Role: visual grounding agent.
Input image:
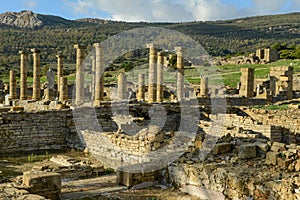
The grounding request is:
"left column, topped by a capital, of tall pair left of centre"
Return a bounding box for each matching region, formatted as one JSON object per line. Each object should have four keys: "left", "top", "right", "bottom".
{"left": 74, "top": 44, "right": 86, "bottom": 105}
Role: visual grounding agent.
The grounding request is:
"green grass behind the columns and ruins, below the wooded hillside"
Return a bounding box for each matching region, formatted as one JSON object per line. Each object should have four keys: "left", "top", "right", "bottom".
{"left": 0, "top": 60, "right": 300, "bottom": 87}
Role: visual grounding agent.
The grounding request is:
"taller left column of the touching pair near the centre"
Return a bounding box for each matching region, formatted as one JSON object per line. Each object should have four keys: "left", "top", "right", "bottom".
{"left": 147, "top": 44, "right": 157, "bottom": 103}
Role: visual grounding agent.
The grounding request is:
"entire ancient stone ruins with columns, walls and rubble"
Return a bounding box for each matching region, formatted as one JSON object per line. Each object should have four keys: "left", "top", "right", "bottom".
{"left": 0, "top": 43, "right": 300, "bottom": 200}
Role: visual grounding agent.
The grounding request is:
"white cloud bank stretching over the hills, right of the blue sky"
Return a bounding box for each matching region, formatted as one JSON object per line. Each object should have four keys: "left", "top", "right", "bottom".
{"left": 69, "top": 0, "right": 299, "bottom": 22}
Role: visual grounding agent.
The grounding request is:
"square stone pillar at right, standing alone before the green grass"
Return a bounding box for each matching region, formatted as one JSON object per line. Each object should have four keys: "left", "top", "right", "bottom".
{"left": 239, "top": 68, "right": 254, "bottom": 98}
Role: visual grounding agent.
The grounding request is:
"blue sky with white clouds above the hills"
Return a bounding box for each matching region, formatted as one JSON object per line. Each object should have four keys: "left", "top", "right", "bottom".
{"left": 0, "top": 0, "right": 300, "bottom": 22}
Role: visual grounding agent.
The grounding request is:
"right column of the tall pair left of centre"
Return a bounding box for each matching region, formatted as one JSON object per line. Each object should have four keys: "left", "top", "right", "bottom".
{"left": 94, "top": 43, "right": 104, "bottom": 106}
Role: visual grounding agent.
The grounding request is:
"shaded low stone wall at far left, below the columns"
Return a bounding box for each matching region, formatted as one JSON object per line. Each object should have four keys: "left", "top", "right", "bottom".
{"left": 0, "top": 111, "right": 69, "bottom": 153}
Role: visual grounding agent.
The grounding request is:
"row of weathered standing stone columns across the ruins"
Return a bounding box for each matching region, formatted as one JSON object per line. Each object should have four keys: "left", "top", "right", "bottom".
{"left": 10, "top": 43, "right": 192, "bottom": 106}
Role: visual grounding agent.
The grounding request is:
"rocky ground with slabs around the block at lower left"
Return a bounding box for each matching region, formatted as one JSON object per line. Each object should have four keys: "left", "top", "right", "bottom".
{"left": 0, "top": 151, "right": 202, "bottom": 200}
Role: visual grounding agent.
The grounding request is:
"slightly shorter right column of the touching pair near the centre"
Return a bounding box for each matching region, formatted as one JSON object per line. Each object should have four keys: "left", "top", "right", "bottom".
{"left": 157, "top": 52, "right": 164, "bottom": 102}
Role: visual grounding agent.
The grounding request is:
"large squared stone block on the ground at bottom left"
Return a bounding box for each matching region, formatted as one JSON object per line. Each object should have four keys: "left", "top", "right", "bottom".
{"left": 23, "top": 171, "right": 61, "bottom": 200}
